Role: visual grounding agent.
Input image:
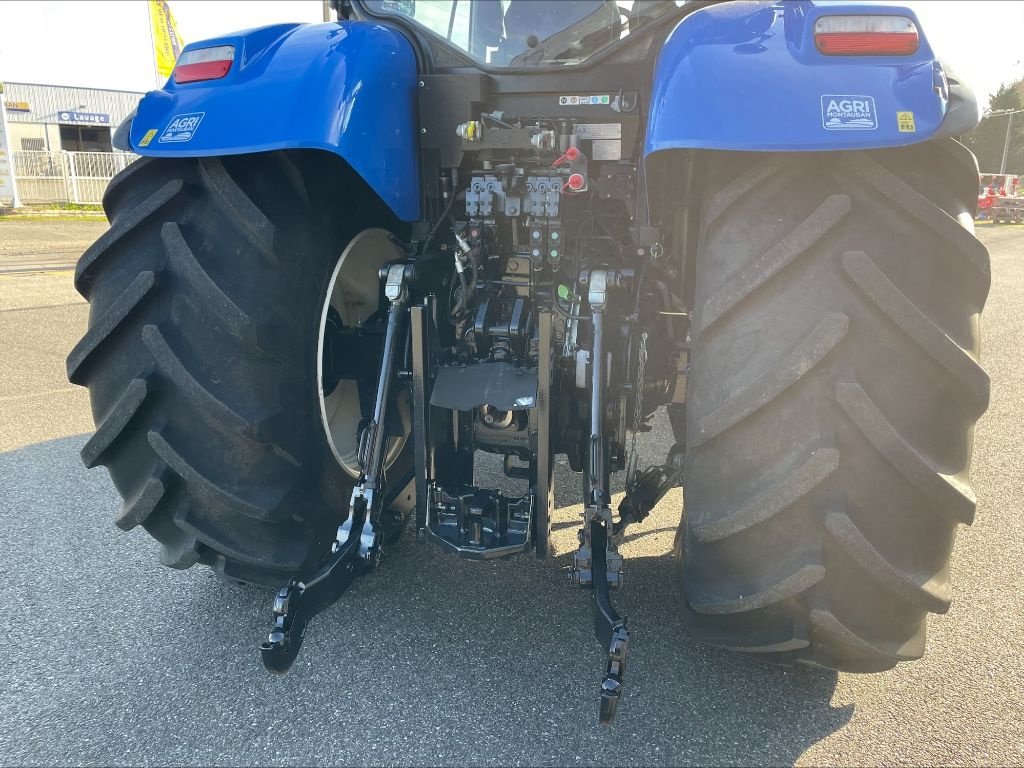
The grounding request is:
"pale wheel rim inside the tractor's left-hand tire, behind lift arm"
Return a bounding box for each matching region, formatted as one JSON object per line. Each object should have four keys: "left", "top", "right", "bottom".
{"left": 316, "top": 229, "right": 412, "bottom": 478}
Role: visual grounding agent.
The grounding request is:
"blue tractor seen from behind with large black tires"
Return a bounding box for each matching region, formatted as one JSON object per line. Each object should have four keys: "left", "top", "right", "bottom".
{"left": 68, "top": 0, "right": 989, "bottom": 722}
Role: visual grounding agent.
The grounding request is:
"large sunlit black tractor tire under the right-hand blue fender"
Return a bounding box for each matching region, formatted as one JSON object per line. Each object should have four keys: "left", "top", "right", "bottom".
{"left": 676, "top": 140, "right": 990, "bottom": 672}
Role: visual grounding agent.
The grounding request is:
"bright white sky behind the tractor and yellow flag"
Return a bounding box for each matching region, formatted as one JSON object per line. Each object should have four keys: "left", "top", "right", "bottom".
{"left": 0, "top": 0, "right": 1024, "bottom": 103}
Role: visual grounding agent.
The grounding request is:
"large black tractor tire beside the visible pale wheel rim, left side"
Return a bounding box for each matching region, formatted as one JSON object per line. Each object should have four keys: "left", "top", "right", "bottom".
{"left": 68, "top": 153, "right": 411, "bottom": 587}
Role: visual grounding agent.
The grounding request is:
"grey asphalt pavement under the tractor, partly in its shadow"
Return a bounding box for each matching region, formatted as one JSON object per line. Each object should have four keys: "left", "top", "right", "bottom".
{"left": 0, "top": 224, "right": 1024, "bottom": 765}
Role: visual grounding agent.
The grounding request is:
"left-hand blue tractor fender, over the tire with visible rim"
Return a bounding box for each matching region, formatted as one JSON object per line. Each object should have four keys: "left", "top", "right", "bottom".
{"left": 129, "top": 22, "right": 420, "bottom": 221}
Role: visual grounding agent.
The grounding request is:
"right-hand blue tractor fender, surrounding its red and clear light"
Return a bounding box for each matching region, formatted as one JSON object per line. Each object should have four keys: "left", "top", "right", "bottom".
{"left": 644, "top": 0, "right": 978, "bottom": 156}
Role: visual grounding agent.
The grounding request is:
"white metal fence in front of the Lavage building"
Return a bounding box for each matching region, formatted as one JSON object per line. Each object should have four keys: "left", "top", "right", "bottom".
{"left": 10, "top": 150, "right": 138, "bottom": 204}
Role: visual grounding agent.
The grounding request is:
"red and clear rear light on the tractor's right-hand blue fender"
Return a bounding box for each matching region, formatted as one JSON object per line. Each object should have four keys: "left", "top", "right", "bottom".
{"left": 814, "top": 15, "right": 921, "bottom": 56}
